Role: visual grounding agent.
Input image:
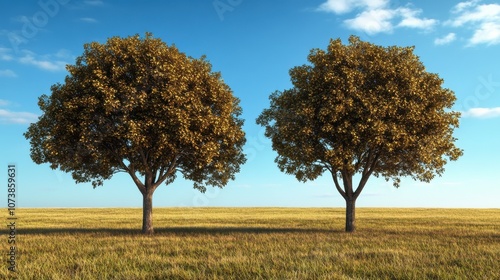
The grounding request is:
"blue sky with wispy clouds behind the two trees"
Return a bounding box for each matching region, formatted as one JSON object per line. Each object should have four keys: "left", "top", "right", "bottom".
{"left": 0, "top": 0, "right": 500, "bottom": 208}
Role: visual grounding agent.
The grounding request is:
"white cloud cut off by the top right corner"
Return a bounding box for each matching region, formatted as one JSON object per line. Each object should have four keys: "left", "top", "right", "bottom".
{"left": 447, "top": 0, "right": 500, "bottom": 45}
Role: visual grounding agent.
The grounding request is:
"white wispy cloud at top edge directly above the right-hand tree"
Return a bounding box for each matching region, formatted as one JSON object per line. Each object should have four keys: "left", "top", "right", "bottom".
{"left": 317, "top": 0, "right": 438, "bottom": 35}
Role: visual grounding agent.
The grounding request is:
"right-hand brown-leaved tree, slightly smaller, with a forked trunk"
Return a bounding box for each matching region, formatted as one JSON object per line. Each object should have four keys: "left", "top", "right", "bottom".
{"left": 257, "top": 36, "right": 462, "bottom": 232}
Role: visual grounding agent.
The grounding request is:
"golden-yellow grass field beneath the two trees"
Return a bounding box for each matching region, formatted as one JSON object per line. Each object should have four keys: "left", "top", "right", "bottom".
{"left": 0, "top": 208, "right": 500, "bottom": 279}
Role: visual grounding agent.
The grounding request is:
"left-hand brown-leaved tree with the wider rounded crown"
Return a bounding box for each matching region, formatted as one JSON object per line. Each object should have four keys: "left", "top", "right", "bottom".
{"left": 25, "top": 33, "right": 245, "bottom": 234}
